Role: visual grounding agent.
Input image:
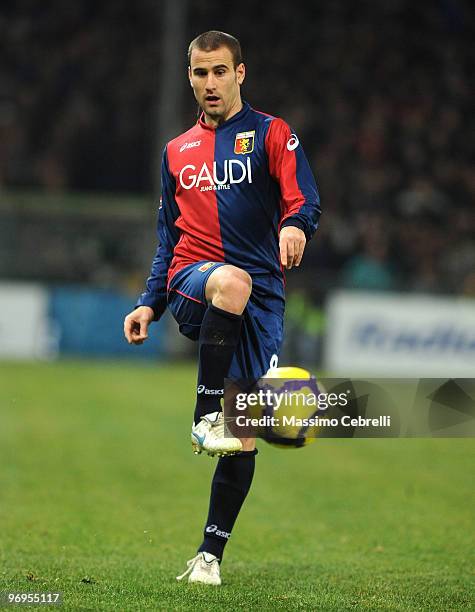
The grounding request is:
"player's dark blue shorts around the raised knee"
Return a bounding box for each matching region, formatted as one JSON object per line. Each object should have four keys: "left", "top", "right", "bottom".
{"left": 168, "top": 261, "right": 285, "bottom": 379}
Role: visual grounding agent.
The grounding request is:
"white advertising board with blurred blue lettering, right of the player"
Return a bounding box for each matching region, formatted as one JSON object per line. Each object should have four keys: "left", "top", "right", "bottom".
{"left": 325, "top": 291, "right": 475, "bottom": 377}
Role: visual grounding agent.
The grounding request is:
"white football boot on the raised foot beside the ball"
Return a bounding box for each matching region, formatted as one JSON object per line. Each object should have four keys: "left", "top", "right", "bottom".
{"left": 191, "top": 412, "right": 242, "bottom": 457}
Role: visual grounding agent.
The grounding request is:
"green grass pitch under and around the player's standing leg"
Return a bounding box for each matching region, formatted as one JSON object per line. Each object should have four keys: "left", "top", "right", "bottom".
{"left": 0, "top": 361, "right": 475, "bottom": 611}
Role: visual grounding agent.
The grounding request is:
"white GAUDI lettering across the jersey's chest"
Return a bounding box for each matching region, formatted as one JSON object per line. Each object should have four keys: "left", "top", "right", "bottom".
{"left": 178, "top": 157, "right": 252, "bottom": 191}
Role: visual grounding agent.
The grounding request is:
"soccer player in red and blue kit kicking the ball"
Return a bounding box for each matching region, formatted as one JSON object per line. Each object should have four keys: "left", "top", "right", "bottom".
{"left": 124, "top": 31, "right": 320, "bottom": 585}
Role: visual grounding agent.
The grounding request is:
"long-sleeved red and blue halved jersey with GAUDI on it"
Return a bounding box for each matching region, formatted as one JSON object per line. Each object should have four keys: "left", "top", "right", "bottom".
{"left": 137, "top": 102, "right": 320, "bottom": 318}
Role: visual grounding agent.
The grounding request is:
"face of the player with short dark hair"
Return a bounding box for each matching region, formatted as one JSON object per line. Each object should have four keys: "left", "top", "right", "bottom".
{"left": 188, "top": 47, "right": 245, "bottom": 123}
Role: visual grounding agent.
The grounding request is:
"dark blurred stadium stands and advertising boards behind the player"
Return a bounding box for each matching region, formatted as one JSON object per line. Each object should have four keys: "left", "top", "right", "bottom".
{"left": 0, "top": 0, "right": 475, "bottom": 375}
